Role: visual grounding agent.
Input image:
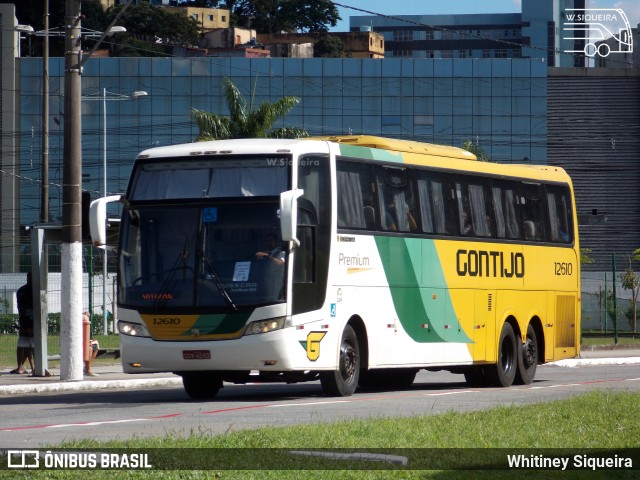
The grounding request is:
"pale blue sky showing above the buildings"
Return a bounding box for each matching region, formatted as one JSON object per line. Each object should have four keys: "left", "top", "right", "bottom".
{"left": 331, "top": 0, "right": 640, "bottom": 31}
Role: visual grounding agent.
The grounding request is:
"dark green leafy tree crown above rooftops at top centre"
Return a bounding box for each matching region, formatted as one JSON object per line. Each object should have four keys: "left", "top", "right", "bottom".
{"left": 226, "top": 0, "right": 340, "bottom": 33}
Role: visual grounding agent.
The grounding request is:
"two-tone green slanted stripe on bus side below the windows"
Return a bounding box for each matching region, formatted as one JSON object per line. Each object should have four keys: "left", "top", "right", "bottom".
{"left": 375, "top": 236, "right": 471, "bottom": 343}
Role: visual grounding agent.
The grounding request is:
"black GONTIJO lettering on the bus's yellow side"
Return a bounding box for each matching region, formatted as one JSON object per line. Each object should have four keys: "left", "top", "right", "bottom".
{"left": 456, "top": 249, "right": 524, "bottom": 278}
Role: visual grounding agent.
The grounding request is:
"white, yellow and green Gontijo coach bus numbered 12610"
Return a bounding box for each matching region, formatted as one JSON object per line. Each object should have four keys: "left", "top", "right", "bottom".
{"left": 90, "top": 136, "right": 580, "bottom": 399}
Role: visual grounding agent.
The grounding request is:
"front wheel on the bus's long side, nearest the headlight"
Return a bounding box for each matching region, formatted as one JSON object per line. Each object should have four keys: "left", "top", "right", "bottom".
{"left": 320, "top": 325, "right": 361, "bottom": 397}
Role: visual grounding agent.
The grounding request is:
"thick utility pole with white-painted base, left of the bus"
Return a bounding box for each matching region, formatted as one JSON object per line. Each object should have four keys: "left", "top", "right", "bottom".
{"left": 60, "top": 0, "right": 83, "bottom": 380}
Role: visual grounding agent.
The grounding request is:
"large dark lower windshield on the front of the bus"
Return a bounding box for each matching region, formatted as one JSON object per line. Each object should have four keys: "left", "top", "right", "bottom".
{"left": 119, "top": 201, "right": 286, "bottom": 311}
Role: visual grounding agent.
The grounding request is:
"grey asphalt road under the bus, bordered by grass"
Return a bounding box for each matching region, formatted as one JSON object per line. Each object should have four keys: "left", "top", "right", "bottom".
{"left": 0, "top": 363, "right": 640, "bottom": 449}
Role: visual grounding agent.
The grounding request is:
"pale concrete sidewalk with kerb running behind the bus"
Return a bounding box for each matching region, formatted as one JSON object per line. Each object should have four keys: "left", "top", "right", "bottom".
{"left": 0, "top": 345, "right": 640, "bottom": 396}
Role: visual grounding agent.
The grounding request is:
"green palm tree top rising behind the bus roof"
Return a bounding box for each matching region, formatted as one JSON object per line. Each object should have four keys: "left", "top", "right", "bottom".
{"left": 191, "top": 78, "right": 309, "bottom": 142}
